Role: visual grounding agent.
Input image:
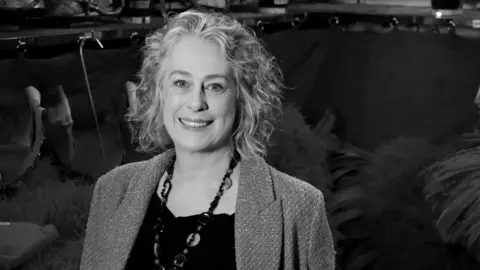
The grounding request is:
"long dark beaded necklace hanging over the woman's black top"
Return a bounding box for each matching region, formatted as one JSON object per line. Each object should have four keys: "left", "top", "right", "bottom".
{"left": 153, "top": 151, "right": 240, "bottom": 270}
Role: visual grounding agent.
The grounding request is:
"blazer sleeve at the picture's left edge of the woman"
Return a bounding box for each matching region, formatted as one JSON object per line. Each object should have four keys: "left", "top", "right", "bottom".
{"left": 80, "top": 178, "right": 107, "bottom": 270}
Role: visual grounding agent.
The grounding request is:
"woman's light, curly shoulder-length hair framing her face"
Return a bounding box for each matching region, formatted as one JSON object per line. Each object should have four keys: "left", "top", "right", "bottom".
{"left": 127, "top": 10, "right": 284, "bottom": 157}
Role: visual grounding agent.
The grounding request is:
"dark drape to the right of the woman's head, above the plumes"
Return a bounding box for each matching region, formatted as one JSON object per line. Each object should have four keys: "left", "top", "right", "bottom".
{"left": 265, "top": 30, "right": 480, "bottom": 148}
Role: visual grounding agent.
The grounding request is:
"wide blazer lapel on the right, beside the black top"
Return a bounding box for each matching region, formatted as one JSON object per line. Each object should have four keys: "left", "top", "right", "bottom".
{"left": 235, "top": 158, "right": 283, "bottom": 270}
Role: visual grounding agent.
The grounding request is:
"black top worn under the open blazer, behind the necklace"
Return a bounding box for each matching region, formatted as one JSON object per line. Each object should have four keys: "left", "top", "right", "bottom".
{"left": 125, "top": 193, "right": 236, "bottom": 270}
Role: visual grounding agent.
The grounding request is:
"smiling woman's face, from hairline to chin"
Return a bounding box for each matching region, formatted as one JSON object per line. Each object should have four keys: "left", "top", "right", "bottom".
{"left": 163, "top": 36, "right": 236, "bottom": 152}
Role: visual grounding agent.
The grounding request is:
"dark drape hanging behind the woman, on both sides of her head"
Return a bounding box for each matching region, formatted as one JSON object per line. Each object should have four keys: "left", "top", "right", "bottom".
{"left": 0, "top": 30, "right": 480, "bottom": 151}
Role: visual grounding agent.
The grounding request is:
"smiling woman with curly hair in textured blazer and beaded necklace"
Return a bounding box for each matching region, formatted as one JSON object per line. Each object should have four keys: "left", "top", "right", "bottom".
{"left": 80, "top": 8, "right": 334, "bottom": 270}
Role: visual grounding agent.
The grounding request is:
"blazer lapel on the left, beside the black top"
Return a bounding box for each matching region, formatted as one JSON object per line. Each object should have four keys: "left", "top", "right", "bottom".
{"left": 106, "top": 150, "right": 173, "bottom": 269}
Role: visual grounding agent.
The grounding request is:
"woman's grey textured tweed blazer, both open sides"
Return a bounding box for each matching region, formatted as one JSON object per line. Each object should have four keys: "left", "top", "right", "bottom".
{"left": 80, "top": 150, "right": 335, "bottom": 270}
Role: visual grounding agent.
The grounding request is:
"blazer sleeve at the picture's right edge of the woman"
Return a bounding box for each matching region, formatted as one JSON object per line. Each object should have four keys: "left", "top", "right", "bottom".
{"left": 308, "top": 193, "right": 335, "bottom": 270}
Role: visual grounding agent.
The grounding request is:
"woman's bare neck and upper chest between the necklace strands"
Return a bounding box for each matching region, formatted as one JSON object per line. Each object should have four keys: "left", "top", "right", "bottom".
{"left": 174, "top": 147, "right": 233, "bottom": 186}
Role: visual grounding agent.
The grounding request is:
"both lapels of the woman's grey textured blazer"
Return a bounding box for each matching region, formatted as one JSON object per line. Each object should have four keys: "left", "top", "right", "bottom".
{"left": 108, "top": 150, "right": 283, "bottom": 269}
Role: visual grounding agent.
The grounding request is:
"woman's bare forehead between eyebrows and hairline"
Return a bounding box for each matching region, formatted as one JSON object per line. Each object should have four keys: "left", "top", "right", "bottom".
{"left": 170, "top": 36, "right": 229, "bottom": 74}
